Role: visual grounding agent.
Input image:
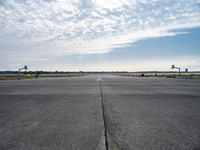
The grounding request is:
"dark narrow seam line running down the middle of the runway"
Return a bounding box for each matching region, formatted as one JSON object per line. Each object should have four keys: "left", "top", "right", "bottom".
{"left": 99, "top": 79, "right": 108, "bottom": 150}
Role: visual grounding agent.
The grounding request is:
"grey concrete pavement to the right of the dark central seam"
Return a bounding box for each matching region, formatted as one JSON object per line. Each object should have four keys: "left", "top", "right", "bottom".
{"left": 102, "top": 77, "right": 200, "bottom": 150}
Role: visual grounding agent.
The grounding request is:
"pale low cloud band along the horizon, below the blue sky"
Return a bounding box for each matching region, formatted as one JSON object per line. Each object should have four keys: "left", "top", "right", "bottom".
{"left": 65, "top": 56, "right": 200, "bottom": 72}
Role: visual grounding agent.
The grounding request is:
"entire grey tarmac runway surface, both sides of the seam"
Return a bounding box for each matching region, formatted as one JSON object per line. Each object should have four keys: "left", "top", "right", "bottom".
{"left": 0, "top": 75, "right": 200, "bottom": 150}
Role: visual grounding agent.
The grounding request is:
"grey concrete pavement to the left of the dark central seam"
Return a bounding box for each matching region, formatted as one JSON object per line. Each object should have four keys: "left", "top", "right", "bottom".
{"left": 0, "top": 77, "right": 105, "bottom": 150}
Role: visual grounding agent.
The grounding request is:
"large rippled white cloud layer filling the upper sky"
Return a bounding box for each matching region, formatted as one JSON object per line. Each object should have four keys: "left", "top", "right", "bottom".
{"left": 0, "top": 0, "right": 200, "bottom": 57}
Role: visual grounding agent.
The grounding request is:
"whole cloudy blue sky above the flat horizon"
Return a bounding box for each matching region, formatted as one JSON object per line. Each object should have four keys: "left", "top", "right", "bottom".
{"left": 0, "top": 0, "right": 200, "bottom": 71}
